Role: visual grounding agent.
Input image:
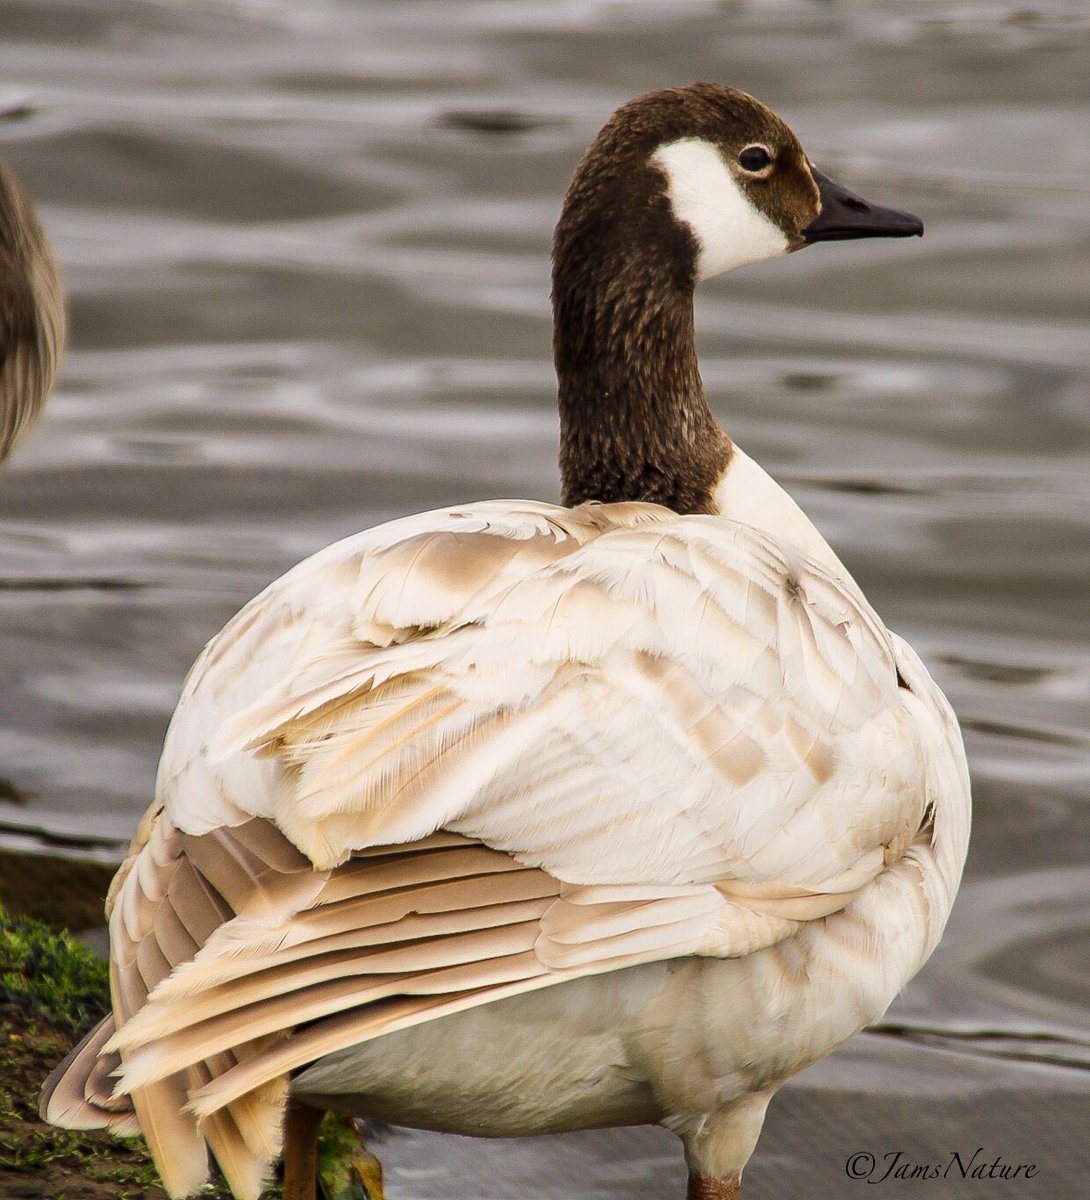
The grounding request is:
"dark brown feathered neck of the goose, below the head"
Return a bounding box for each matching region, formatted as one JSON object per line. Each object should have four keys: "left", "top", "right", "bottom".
{"left": 553, "top": 201, "right": 730, "bottom": 512}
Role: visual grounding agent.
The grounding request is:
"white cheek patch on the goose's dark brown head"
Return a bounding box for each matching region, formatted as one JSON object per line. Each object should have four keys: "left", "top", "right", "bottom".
{"left": 651, "top": 138, "right": 787, "bottom": 280}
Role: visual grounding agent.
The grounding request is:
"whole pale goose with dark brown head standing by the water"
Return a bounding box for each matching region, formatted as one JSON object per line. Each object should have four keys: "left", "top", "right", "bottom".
{"left": 42, "top": 84, "right": 970, "bottom": 1200}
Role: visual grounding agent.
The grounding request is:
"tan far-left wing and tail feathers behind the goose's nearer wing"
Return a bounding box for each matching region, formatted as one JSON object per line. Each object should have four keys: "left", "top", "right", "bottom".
{"left": 42, "top": 806, "right": 323, "bottom": 1196}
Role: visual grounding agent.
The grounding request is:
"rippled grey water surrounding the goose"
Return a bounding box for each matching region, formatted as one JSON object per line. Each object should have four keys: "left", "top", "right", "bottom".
{"left": 0, "top": 0, "right": 1090, "bottom": 1200}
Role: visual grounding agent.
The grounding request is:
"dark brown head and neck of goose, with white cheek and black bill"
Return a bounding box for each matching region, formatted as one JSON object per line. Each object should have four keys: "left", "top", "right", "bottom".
{"left": 552, "top": 84, "right": 923, "bottom": 512}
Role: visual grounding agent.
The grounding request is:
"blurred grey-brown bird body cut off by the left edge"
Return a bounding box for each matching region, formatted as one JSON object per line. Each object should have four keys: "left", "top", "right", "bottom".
{"left": 0, "top": 151, "right": 65, "bottom": 462}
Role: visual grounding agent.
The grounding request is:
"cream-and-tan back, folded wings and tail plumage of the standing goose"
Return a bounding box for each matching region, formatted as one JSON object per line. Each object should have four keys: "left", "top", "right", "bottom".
{"left": 47, "top": 502, "right": 965, "bottom": 1195}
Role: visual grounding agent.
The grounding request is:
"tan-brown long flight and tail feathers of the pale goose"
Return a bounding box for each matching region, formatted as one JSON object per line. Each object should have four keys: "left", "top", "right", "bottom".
{"left": 42, "top": 809, "right": 558, "bottom": 1198}
